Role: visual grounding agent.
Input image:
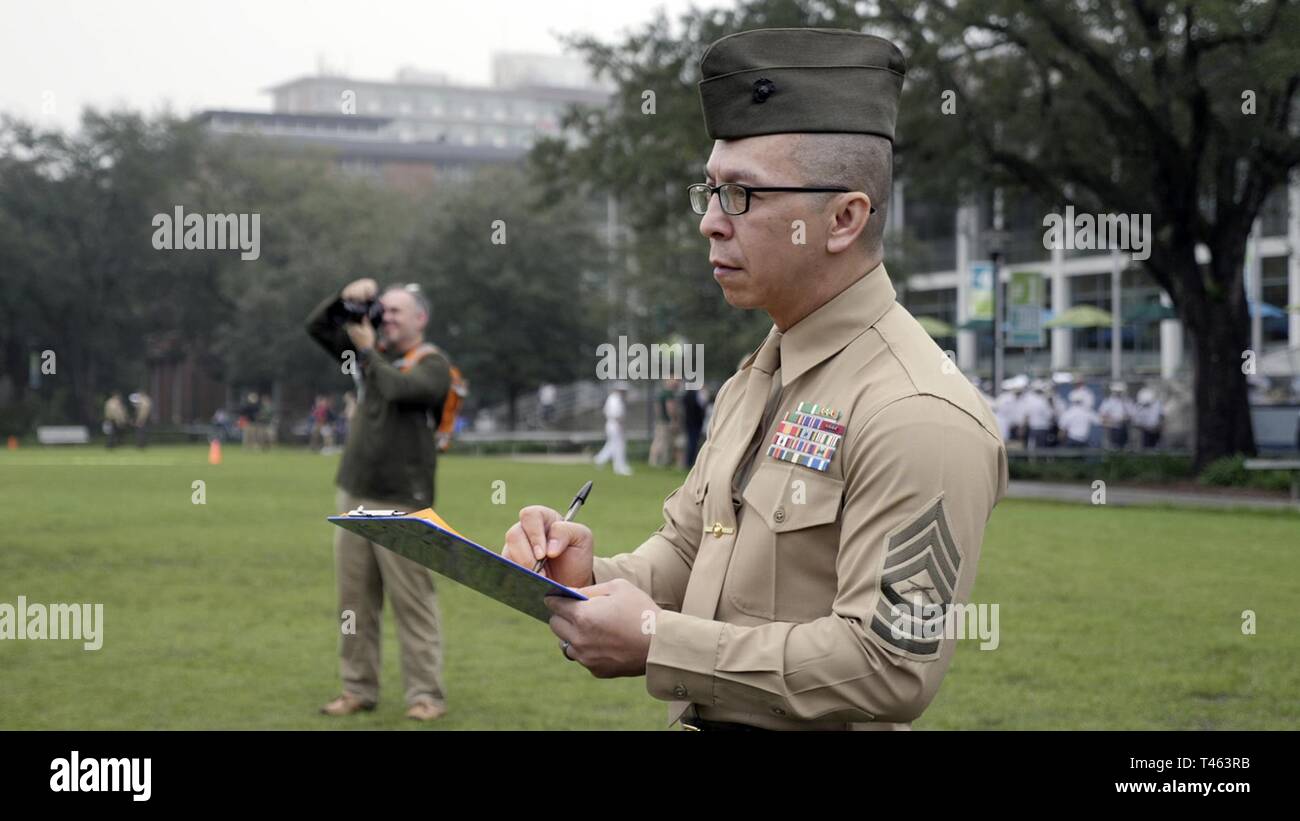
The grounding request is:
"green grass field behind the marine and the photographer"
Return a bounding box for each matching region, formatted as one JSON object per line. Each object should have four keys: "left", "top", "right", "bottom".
{"left": 0, "top": 447, "right": 1300, "bottom": 730}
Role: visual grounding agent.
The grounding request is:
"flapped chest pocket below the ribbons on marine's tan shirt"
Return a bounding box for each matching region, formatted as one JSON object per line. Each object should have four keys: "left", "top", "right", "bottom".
{"left": 724, "top": 457, "right": 844, "bottom": 622}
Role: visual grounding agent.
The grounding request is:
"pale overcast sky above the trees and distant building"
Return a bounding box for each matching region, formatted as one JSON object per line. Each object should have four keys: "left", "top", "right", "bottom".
{"left": 0, "top": 0, "right": 712, "bottom": 129}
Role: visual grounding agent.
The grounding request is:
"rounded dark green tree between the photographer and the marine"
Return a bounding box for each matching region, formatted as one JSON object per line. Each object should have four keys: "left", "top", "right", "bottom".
{"left": 403, "top": 168, "right": 603, "bottom": 430}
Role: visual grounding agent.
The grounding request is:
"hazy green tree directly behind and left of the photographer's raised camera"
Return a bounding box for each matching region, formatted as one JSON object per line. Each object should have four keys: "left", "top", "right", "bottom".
{"left": 195, "top": 139, "right": 416, "bottom": 397}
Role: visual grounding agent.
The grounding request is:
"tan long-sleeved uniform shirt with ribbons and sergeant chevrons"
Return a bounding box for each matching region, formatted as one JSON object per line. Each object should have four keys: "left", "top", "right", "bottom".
{"left": 594, "top": 265, "right": 1006, "bottom": 730}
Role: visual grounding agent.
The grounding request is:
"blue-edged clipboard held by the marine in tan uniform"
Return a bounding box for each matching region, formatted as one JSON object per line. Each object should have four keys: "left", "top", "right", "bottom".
{"left": 329, "top": 508, "right": 586, "bottom": 622}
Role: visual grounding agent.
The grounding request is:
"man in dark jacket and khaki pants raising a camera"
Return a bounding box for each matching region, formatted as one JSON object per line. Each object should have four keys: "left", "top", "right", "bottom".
{"left": 307, "top": 279, "right": 451, "bottom": 721}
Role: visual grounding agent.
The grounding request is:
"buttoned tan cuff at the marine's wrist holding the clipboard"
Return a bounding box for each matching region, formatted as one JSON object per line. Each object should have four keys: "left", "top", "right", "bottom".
{"left": 646, "top": 611, "right": 725, "bottom": 707}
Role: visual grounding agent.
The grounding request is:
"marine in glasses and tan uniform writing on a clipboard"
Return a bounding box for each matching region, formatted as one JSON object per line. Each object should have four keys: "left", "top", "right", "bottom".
{"left": 504, "top": 29, "right": 1006, "bottom": 730}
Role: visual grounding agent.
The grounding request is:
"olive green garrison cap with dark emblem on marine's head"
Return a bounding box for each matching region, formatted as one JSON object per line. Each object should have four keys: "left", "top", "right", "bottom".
{"left": 699, "top": 29, "right": 907, "bottom": 143}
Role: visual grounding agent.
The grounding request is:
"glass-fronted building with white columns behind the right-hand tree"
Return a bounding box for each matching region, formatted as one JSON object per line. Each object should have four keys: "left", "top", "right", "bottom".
{"left": 891, "top": 181, "right": 1300, "bottom": 379}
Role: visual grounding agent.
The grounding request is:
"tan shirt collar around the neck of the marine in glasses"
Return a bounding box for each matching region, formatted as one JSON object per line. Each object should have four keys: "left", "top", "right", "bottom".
{"left": 772, "top": 262, "right": 894, "bottom": 385}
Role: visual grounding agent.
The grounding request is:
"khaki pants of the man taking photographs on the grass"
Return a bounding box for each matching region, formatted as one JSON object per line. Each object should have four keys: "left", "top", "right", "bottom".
{"left": 334, "top": 490, "right": 446, "bottom": 705}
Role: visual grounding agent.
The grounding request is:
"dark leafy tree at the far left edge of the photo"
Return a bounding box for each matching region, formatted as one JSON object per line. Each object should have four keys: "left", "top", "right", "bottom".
{"left": 0, "top": 110, "right": 216, "bottom": 423}
